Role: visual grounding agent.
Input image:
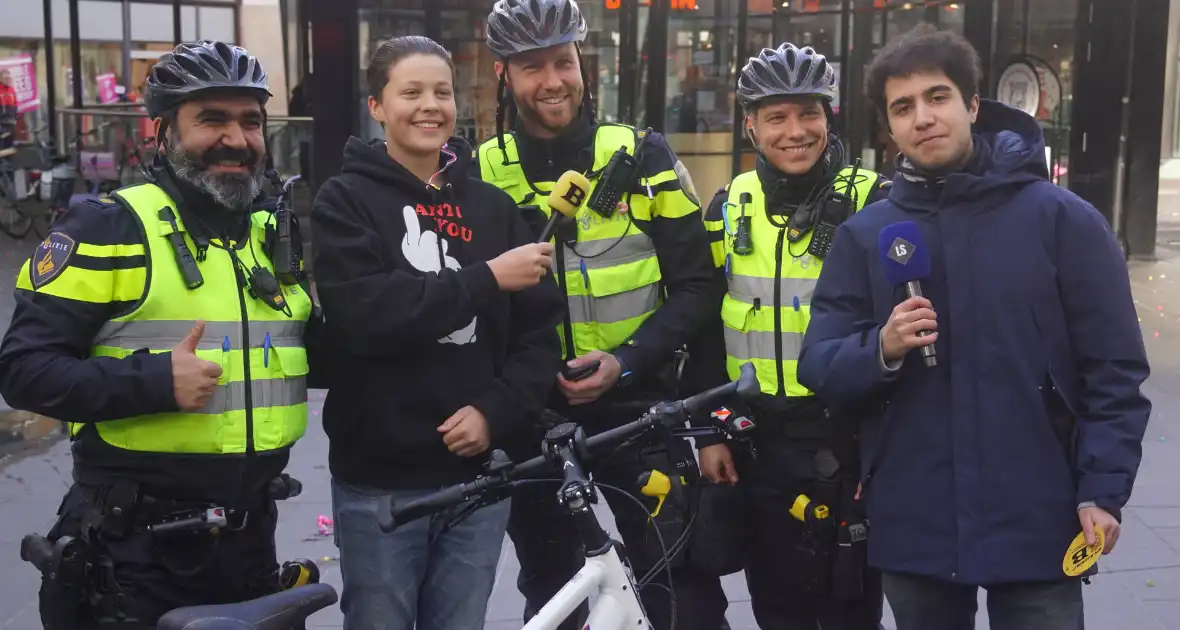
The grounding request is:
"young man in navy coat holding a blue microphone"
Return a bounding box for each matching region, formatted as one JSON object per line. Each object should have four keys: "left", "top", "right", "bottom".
{"left": 799, "top": 27, "right": 1151, "bottom": 630}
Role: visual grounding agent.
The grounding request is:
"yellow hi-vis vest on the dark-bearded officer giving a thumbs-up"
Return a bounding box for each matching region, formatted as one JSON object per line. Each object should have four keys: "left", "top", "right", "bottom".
{"left": 70, "top": 184, "right": 312, "bottom": 454}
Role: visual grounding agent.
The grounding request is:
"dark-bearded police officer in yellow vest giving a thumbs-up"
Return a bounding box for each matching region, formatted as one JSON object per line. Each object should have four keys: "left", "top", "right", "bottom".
{"left": 0, "top": 41, "right": 313, "bottom": 629}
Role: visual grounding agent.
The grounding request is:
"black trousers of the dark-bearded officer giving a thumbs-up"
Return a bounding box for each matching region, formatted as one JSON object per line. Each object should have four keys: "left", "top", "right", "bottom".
{"left": 40, "top": 486, "right": 280, "bottom": 630}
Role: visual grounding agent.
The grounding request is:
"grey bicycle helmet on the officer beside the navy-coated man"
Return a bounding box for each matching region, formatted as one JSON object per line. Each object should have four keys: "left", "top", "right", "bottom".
{"left": 738, "top": 44, "right": 837, "bottom": 109}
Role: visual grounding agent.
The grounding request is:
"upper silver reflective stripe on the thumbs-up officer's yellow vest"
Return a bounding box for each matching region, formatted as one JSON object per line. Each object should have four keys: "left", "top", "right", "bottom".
{"left": 94, "top": 320, "right": 304, "bottom": 350}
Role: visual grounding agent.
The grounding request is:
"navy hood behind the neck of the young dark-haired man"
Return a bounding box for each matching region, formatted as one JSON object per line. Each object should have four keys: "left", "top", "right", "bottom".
{"left": 890, "top": 99, "right": 1049, "bottom": 211}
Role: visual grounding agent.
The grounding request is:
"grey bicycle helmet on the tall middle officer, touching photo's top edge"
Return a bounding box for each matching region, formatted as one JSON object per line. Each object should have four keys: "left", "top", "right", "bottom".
{"left": 487, "top": 0, "right": 586, "bottom": 57}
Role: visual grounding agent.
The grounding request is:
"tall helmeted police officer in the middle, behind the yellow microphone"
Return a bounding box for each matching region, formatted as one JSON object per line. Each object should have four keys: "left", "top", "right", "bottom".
{"left": 476, "top": 0, "right": 726, "bottom": 630}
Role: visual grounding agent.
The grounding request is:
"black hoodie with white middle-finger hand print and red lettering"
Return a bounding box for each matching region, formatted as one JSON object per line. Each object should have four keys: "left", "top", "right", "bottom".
{"left": 312, "top": 138, "right": 565, "bottom": 488}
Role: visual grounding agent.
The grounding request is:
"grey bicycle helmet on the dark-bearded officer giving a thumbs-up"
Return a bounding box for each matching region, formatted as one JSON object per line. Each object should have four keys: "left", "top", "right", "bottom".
{"left": 144, "top": 40, "right": 271, "bottom": 118}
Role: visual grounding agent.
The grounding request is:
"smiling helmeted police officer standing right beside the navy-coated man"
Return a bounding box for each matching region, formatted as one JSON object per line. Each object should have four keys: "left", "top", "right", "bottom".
{"left": 696, "top": 44, "right": 887, "bottom": 630}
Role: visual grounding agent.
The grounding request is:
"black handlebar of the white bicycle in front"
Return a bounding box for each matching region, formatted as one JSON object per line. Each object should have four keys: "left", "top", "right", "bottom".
{"left": 380, "top": 363, "right": 760, "bottom": 533}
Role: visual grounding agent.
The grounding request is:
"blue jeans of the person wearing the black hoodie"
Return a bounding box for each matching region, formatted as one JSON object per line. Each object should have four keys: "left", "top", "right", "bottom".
{"left": 332, "top": 479, "right": 510, "bottom": 630}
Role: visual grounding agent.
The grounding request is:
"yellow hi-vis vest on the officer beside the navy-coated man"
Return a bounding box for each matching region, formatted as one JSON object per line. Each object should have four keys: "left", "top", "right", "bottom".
{"left": 713, "top": 166, "right": 878, "bottom": 396}
